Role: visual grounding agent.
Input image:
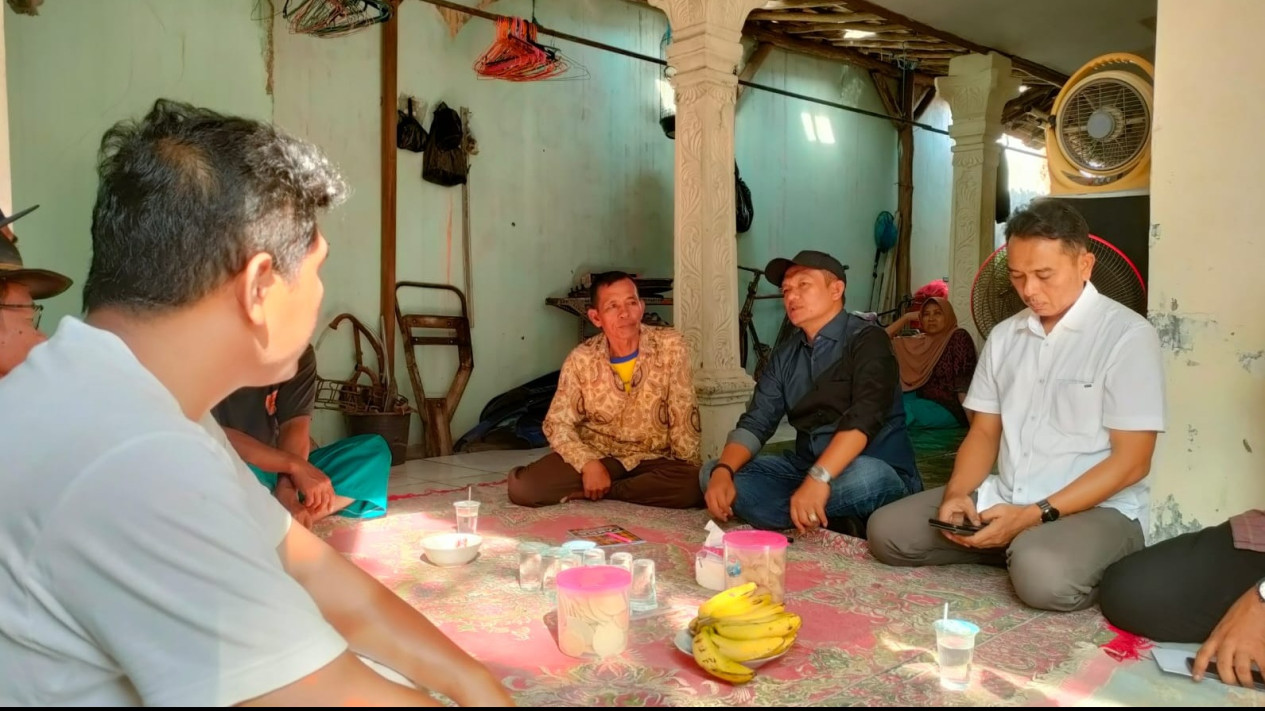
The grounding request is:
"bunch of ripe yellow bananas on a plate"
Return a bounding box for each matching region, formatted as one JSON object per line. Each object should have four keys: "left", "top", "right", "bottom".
{"left": 689, "top": 582, "right": 802, "bottom": 684}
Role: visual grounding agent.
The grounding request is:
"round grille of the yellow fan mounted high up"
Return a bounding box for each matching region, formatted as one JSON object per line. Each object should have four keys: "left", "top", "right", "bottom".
{"left": 1058, "top": 77, "right": 1151, "bottom": 173}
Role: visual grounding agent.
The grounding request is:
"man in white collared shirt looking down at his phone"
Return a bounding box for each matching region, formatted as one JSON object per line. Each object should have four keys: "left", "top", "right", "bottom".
{"left": 869, "top": 200, "right": 1164, "bottom": 610}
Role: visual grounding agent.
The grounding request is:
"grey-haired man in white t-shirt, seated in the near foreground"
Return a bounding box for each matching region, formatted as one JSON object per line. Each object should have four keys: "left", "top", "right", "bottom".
{"left": 0, "top": 100, "right": 510, "bottom": 706}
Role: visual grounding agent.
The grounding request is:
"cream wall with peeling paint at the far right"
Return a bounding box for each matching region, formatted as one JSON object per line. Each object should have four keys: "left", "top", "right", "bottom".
{"left": 1150, "top": 0, "right": 1265, "bottom": 539}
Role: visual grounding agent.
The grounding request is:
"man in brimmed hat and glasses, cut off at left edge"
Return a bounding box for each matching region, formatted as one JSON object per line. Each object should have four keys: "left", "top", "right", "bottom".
{"left": 0, "top": 205, "right": 71, "bottom": 377}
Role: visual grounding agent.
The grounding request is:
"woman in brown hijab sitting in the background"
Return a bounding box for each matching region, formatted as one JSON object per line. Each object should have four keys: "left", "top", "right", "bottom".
{"left": 888, "top": 296, "right": 978, "bottom": 429}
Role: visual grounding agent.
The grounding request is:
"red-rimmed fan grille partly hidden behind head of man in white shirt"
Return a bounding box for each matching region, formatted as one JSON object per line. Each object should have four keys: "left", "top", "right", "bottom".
{"left": 970, "top": 234, "right": 1146, "bottom": 338}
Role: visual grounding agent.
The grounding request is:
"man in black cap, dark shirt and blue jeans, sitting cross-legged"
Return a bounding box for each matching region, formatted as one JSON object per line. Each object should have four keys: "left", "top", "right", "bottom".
{"left": 700, "top": 250, "right": 922, "bottom": 536}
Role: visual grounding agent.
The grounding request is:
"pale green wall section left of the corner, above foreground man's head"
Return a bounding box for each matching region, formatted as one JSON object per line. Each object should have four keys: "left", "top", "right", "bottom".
{"left": 4, "top": 0, "right": 272, "bottom": 323}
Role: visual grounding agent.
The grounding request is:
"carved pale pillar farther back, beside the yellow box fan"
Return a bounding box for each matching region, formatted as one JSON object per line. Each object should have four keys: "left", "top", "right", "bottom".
{"left": 936, "top": 52, "right": 1020, "bottom": 344}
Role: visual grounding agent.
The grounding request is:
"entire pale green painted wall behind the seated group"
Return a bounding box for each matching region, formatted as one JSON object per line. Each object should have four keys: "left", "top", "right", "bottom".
{"left": 5, "top": 0, "right": 947, "bottom": 447}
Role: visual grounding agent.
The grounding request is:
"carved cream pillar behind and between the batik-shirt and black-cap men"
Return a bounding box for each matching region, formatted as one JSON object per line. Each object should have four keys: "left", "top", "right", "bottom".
{"left": 650, "top": 0, "right": 764, "bottom": 459}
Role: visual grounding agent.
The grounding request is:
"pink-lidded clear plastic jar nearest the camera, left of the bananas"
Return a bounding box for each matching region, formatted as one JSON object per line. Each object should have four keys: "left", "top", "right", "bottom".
{"left": 558, "top": 566, "right": 633, "bottom": 658}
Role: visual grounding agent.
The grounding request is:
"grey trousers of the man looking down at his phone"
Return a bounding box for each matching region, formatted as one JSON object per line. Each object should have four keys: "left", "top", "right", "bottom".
{"left": 867, "top": 487, "right": 1144, "bottom": 612}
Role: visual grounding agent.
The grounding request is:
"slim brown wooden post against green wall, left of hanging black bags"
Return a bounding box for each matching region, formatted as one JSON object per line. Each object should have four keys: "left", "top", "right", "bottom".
{"left": 378, "top": 1, "right": 397, "bottom": 374}
